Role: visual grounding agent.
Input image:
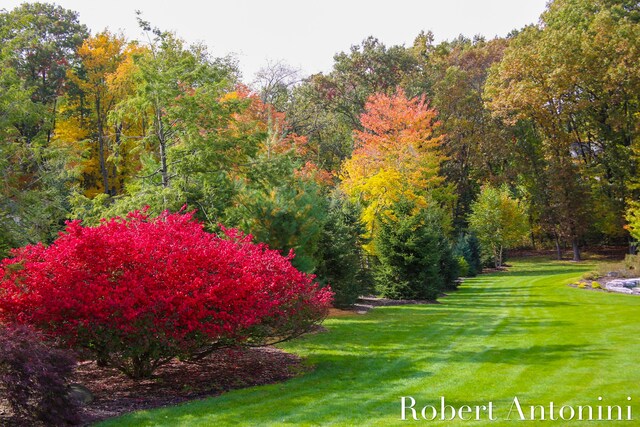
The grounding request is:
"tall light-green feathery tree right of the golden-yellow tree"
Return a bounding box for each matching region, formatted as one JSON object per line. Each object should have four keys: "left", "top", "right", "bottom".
{"left": 106, "top": 20, "right": 241, "bottom": 214}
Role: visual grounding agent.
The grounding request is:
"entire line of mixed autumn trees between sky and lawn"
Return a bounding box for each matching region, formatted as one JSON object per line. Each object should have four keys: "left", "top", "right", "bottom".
{"left": 0, "top": 0, "right": 640, "bottom": 304}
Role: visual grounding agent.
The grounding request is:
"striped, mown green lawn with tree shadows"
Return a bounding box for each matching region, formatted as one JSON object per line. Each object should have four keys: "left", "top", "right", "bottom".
{"left": 101, "top": 262, "right": 640, "bottom": 426}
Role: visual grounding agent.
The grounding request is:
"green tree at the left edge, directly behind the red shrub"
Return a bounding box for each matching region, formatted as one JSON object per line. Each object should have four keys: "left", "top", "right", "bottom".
{"left": 0, "top": 50, "right": 70, "bottom": 258}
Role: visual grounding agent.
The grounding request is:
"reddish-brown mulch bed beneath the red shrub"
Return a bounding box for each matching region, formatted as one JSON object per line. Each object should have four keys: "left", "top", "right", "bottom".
{"left": 0, "top": 347, "right": 310, "bottom": 426}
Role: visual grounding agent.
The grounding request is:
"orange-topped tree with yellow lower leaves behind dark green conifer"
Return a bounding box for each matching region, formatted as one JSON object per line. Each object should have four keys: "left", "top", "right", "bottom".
{"left": 341, "top": 89, "right": 450, "bottom": 247}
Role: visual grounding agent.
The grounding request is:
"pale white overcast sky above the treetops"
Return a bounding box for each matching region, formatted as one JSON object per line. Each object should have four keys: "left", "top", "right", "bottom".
{"left": 0, "top": 0, "right": 546, "bottom": 82}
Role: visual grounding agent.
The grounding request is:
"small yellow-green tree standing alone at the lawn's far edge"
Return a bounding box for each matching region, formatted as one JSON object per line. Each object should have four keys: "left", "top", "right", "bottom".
{"left": 469, "top": 186, "right": 529, "bottom": 268}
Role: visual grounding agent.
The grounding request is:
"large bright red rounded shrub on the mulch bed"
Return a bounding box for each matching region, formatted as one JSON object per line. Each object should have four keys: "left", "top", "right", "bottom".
{"left": 0, "top": 211, "right": 331, "bottom": 377}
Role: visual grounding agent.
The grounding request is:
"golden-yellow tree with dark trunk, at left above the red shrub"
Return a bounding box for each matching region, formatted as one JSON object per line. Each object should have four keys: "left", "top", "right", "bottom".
{"left": 56, "top": 31, "right": 144, "bottom": 197}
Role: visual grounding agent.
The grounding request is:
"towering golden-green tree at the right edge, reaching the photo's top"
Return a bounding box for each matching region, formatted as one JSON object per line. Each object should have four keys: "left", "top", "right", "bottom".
{"left": 486, "top": 0, "right": 640, "bottom": 260}
